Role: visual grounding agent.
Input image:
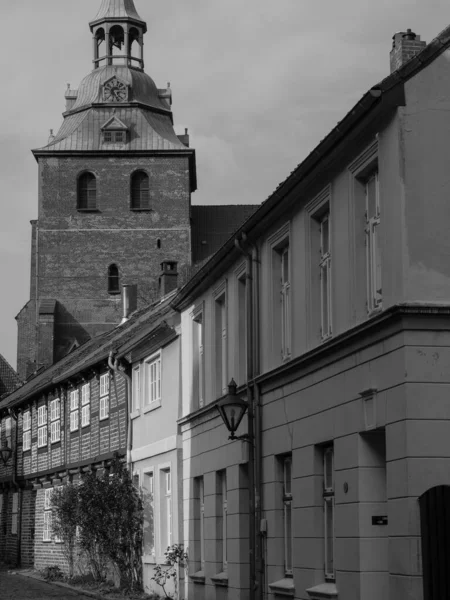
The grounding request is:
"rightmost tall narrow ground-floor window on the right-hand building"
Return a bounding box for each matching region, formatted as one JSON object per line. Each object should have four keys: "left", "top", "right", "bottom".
{"left": 323, "top": 446, "right": 335, "bottom": 581}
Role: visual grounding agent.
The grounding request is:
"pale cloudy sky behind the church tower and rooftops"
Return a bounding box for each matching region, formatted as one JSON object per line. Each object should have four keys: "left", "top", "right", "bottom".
{"left": 0, "top": 0, "right": 450, "bottom": 367}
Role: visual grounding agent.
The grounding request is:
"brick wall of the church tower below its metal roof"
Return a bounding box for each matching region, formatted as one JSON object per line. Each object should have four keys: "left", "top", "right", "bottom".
{"left": 33, "top": 156, "right": 190, "bottom": 360}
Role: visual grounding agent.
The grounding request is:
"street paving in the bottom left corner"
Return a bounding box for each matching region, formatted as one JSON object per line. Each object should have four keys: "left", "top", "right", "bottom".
{"left": 0, "top": 571, "right": 92, "bottom": 600}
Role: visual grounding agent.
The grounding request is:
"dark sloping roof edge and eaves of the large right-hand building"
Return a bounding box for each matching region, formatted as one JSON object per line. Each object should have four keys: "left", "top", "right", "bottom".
{"left": 172, "top": 26, "right": 450, "bottom": 310}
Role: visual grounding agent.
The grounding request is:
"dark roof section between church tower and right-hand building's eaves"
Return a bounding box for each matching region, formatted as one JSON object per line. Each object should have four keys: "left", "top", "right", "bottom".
{"left": 191, "top": 204, "right": 259, "bottom": 264}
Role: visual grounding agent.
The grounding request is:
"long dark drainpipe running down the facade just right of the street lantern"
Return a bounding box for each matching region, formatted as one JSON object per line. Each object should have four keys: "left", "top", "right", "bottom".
{"left": 235, "top": 234, "right": 263, "bottom": 600}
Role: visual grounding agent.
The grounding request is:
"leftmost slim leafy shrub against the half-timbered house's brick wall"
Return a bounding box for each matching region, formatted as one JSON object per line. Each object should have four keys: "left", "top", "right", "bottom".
{"left": 51, "top": 483, "right": 79, "bottom": 579}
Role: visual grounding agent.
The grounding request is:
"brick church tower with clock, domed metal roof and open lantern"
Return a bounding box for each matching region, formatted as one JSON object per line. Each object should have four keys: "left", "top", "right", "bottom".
{"left": 17, "top": 0, "right": 196, "bottom": 378}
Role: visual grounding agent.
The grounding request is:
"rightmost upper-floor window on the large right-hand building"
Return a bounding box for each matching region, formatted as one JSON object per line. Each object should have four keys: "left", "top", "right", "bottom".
{"left": 365, "top": 168, "right": 383, "bottom": 314}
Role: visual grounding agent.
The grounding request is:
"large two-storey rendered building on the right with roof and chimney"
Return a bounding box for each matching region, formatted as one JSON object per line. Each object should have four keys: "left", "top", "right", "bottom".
{"left": 174, "top": 29, "right": 450, "bottom": 600}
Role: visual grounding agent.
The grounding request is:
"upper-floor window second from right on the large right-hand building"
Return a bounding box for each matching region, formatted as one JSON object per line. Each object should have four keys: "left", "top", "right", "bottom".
{"left": 319, "top": 210, "right": 333, "bottom": 340}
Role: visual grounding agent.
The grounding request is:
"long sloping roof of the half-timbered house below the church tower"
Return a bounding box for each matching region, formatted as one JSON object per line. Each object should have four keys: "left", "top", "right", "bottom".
{"left": 0, "top": 296, "right": 173, "bottom": 409}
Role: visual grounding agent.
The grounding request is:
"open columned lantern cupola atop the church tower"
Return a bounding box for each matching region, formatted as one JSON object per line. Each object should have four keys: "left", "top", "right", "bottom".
{"left": 89, "top": 0, "right": 147, "bottom": 69}
